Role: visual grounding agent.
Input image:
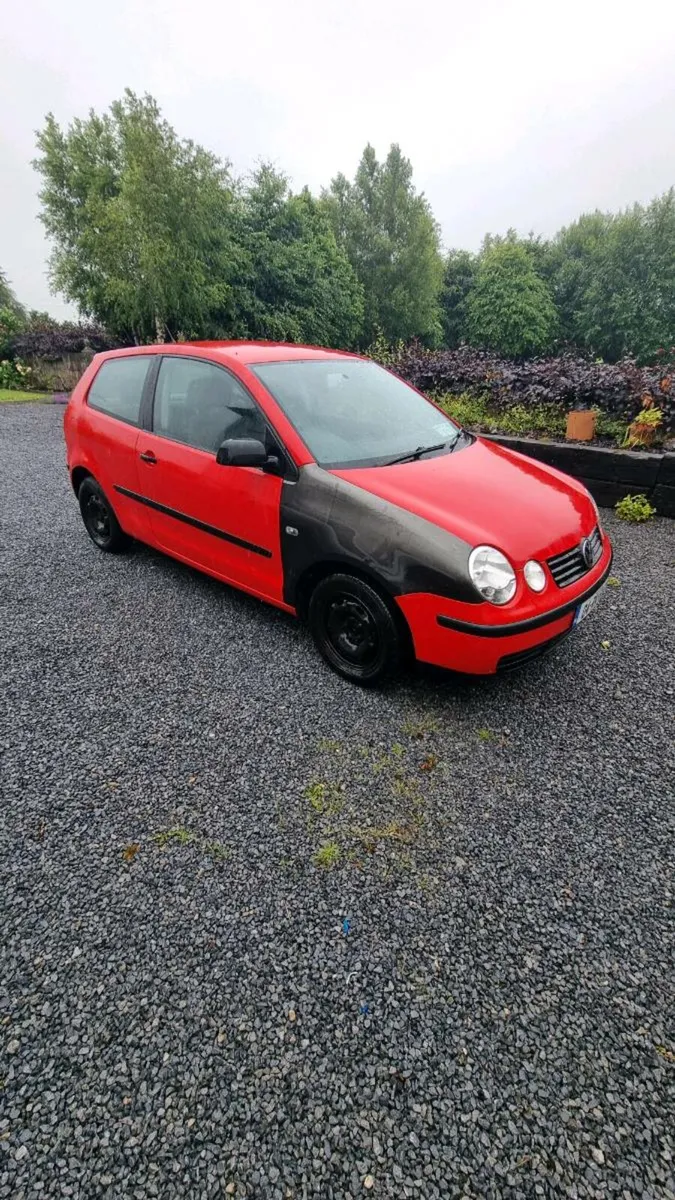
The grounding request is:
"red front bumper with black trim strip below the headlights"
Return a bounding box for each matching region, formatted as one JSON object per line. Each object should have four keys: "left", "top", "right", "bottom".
{"left": 398, "top": 535, "right": 613, "bottom": 674}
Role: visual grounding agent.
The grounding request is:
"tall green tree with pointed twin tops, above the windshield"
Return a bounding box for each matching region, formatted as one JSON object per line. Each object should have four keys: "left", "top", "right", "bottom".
{"left": 323, "top": 145, "right": 443, "bottom": 344}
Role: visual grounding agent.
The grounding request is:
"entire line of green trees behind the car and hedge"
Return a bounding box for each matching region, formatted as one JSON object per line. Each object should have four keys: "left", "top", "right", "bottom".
{"left": 30, "top": 90, "right": 675, "bottom": 364}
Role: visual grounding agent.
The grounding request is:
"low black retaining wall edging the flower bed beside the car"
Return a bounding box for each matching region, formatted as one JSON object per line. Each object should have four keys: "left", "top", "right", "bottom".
{"left": 480, "top": 433, "right": 675, "bottom": 517}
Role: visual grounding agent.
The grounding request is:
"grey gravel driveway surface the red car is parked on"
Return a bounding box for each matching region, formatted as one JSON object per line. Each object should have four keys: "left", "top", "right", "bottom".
{"left": 0, "top": 406, "right": 675, "bottom": 1200}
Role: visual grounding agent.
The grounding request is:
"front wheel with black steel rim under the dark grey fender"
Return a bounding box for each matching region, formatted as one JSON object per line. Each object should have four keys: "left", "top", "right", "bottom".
{"left": 307, "top": 575, "right": 404, "bottom": 686}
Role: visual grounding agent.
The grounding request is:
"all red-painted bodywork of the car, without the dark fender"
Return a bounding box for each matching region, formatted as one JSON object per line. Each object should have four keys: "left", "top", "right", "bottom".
{"left": 64, "top": 342, "right": 611, "bottom": 673}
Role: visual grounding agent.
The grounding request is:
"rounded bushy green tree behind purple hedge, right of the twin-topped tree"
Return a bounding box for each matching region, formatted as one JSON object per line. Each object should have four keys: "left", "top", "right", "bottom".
{"left": 467, "top": 239, "right": 557, "bottom": 358}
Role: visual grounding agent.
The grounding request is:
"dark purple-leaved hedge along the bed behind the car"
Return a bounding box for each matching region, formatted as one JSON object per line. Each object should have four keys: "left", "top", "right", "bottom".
{"left": 372, "top": 344, "right": 675, "bottom": 432}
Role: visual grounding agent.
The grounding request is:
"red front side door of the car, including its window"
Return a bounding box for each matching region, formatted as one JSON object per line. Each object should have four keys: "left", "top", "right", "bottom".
{"left": 137, "top": 355, "right": 283, "bottom": 602}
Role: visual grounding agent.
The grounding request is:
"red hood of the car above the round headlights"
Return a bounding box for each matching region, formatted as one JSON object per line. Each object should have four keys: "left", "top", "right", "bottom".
{"left": 331, "top": 438, "right": 597, "bottom": 566}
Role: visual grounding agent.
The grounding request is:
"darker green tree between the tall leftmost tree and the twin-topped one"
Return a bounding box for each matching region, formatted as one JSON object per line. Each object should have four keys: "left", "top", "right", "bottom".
{"left": 225, "top": 166, "right": 363, "bottom": 347}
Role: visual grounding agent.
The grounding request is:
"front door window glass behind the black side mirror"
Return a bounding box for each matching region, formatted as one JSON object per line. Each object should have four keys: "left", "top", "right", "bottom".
{"left": 153, "top": 356, "right": 265, "bottom": 454}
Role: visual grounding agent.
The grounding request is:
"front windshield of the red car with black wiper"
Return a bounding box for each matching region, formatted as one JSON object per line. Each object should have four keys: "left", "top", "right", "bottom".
{"left": 251, "top": 358, "right": 458, "bottom": 467}
